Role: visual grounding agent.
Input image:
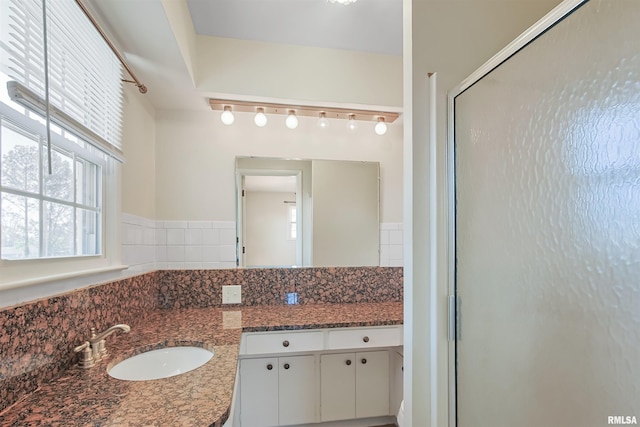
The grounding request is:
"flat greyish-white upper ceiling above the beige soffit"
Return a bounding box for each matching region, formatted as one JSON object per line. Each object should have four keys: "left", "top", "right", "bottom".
{"left": 187, "top": 0, "right": 402, "bottom": 55}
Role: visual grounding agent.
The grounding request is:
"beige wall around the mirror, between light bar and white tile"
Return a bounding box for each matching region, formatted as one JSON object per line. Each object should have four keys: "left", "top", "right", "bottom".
{"left": 156, "top": 111, "right": 402, "bottom": 222}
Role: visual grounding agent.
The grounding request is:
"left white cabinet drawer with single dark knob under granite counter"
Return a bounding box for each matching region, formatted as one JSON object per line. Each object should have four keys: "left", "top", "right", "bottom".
{"left": 246, "top": 331, "right": 324, "bottom": 354}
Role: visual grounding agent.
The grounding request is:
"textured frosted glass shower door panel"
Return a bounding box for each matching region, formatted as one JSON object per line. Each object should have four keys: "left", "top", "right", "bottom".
{"left": 454, "top": 0, "right": 640, "bottom": 427}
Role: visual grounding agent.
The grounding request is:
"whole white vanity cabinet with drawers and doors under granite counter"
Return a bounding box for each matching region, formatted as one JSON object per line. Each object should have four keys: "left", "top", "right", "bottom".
{"left": 234, "top": 325, "right": 402, "bottom": 427}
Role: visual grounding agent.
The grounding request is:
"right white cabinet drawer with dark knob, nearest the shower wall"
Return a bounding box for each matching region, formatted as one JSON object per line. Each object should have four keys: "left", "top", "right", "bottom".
{"left": 327, "top": 326, "right": 402, "bottom": 350}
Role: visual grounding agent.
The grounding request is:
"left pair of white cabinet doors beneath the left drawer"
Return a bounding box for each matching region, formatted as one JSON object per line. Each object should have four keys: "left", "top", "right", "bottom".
{"left": 240, "top": 355, "right": 317, "bottom": 427}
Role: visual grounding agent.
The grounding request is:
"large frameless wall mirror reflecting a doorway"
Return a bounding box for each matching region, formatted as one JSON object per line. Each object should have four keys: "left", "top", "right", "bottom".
{"left": 236, "top": 157, "right": 380, "bottom": 267}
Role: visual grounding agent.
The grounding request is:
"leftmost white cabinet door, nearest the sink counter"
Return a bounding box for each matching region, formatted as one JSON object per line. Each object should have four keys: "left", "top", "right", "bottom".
{"left": 240, "top": 358, "right": 278, "bottom": 427}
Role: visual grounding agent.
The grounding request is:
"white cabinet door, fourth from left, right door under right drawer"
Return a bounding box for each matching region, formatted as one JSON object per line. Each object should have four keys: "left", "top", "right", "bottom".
{"left": 356, "top": 350, "right": 389, "bottom": 418}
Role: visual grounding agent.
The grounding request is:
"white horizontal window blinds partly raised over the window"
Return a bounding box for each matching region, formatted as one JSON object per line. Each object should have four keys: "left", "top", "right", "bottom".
{"left": 0, "top": 0, "right": 122, "bottom": 159}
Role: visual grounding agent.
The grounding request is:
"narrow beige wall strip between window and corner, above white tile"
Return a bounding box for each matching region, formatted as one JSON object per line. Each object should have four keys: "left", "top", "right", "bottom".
{"left": 122, "top": 85, "right": 156, "bottom": 219}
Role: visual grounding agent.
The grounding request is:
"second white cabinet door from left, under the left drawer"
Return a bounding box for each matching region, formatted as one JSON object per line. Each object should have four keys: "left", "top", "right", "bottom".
{"left": 278, "top": 356, "right": 316, "bottom": 426}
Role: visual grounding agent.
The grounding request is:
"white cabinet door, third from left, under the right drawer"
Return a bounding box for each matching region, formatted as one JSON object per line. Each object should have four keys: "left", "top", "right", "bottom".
{"left": 320, "top": 353, "right": 356, "bottom": 421}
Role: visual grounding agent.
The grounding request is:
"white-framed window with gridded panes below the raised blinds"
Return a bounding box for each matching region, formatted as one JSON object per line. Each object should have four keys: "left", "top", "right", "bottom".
{"left": 0, "top": 104, "right": 105, "bottom": 260}
